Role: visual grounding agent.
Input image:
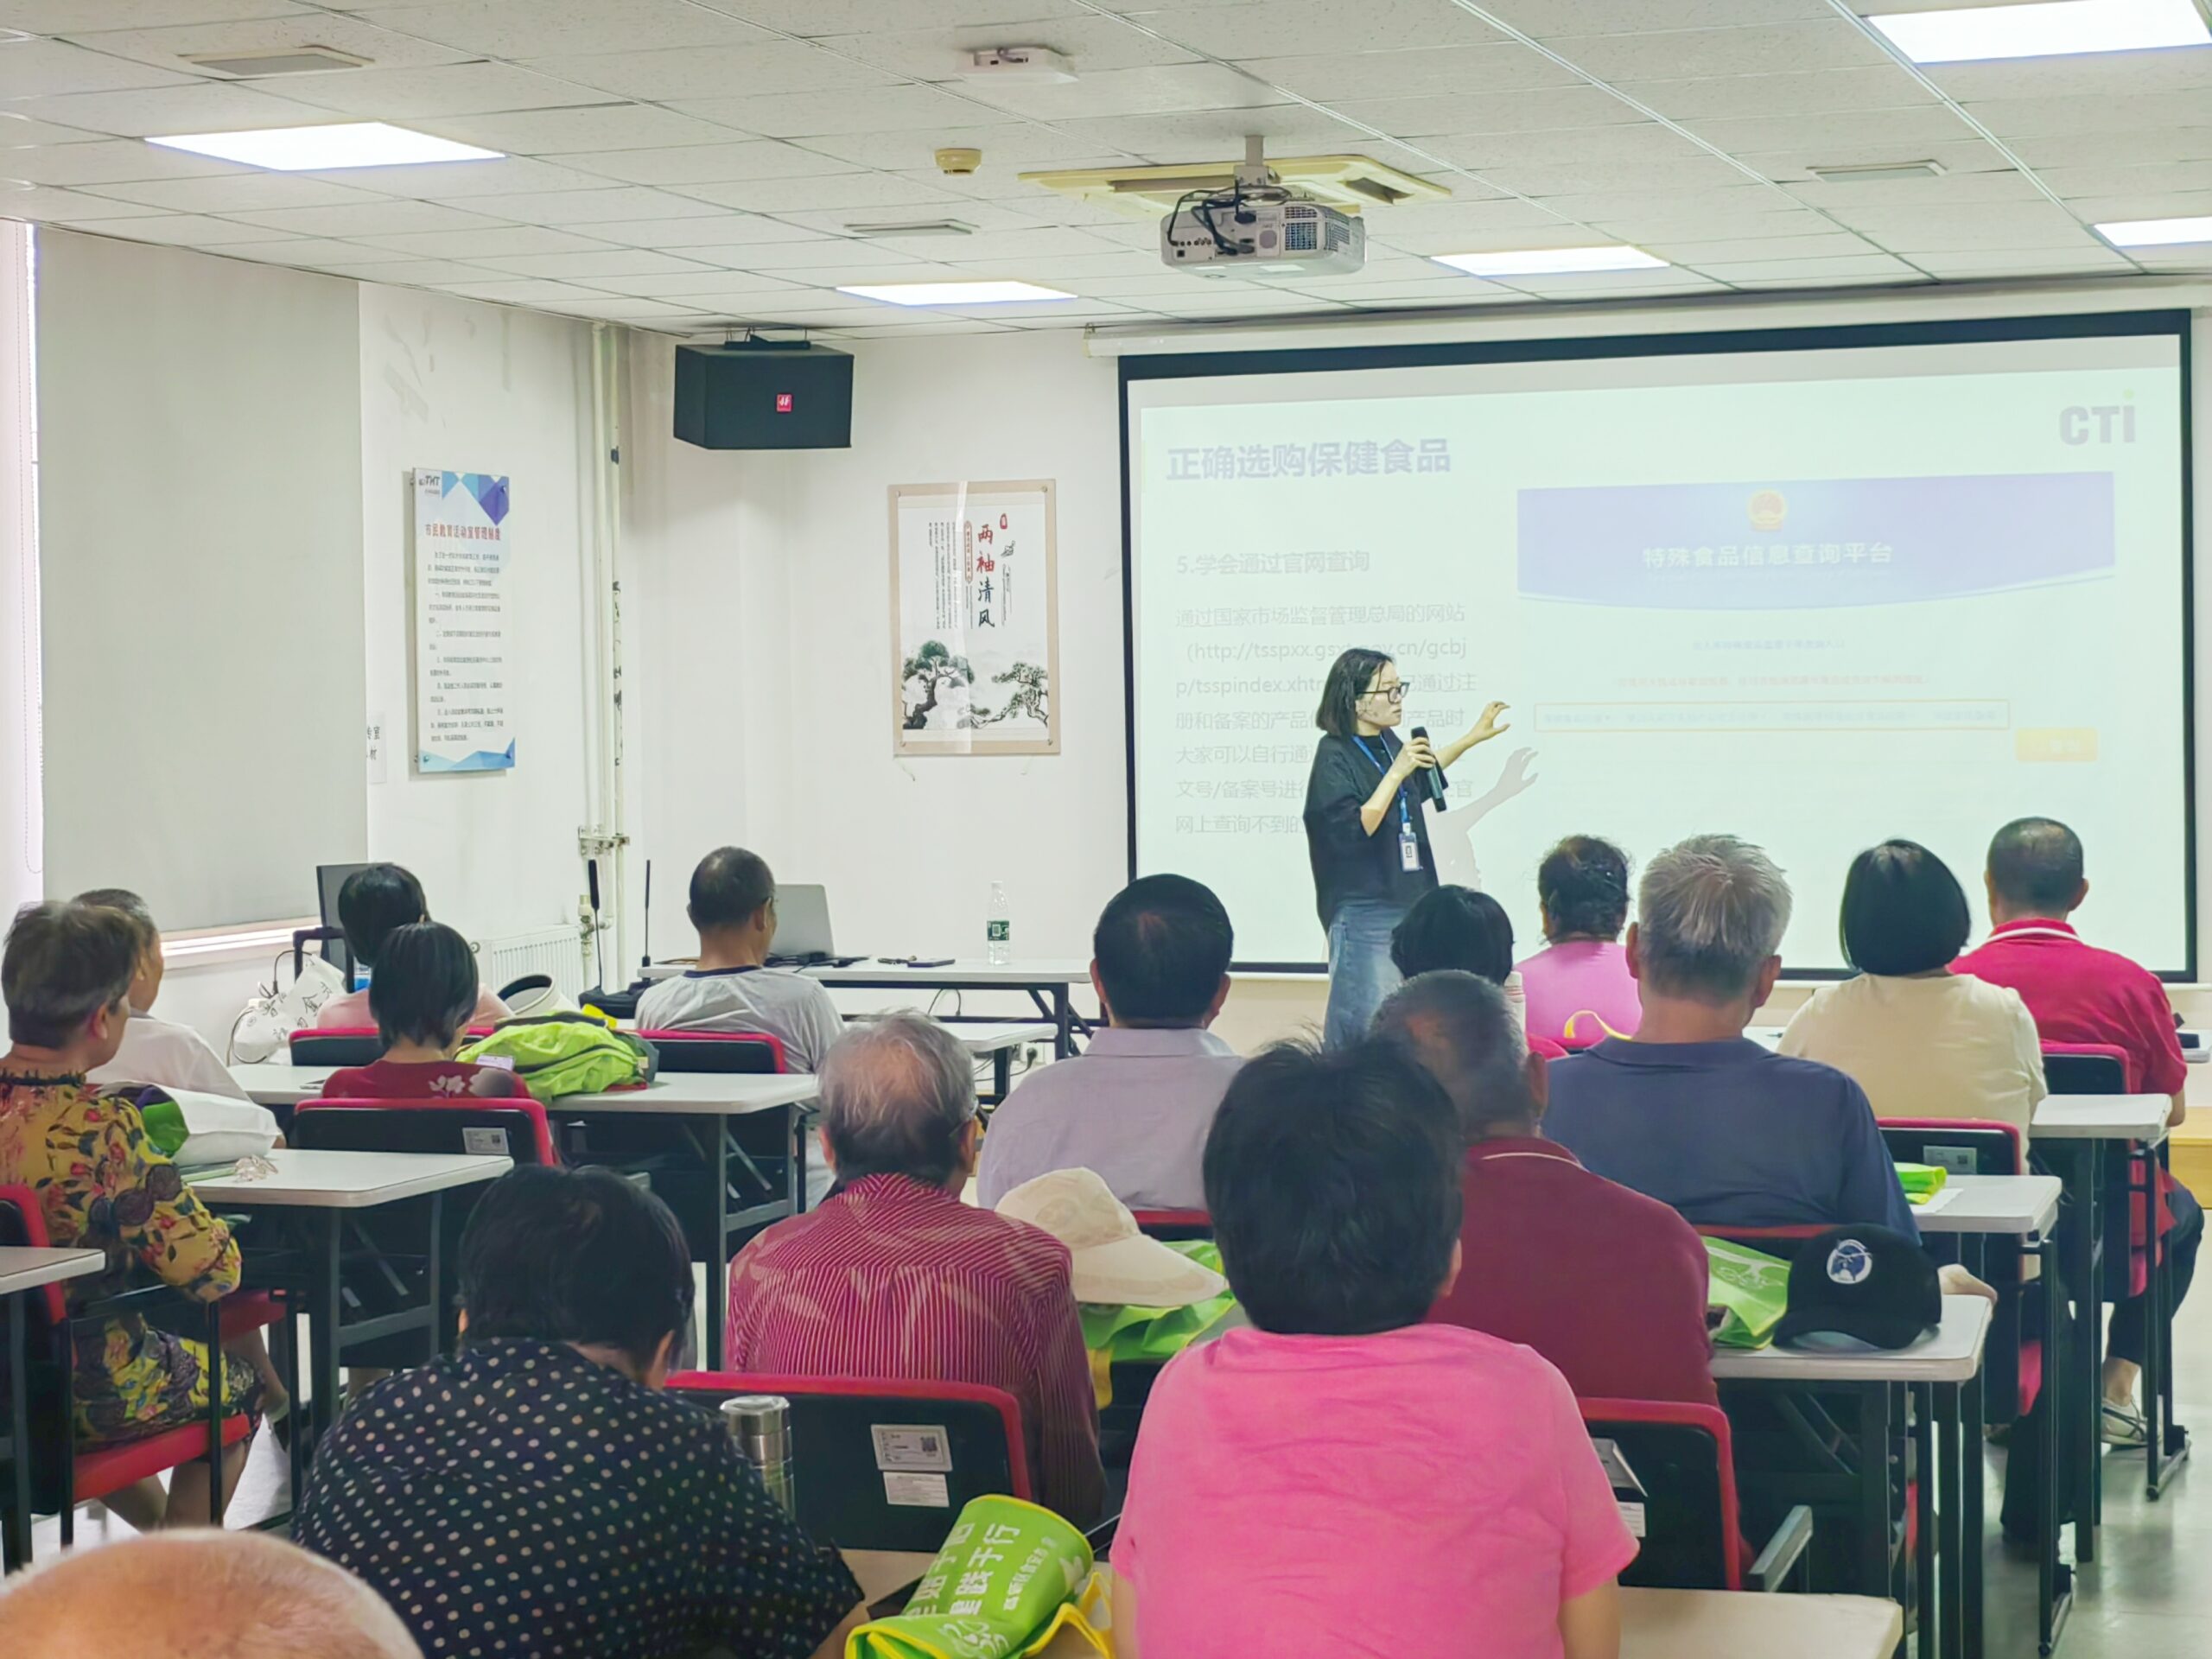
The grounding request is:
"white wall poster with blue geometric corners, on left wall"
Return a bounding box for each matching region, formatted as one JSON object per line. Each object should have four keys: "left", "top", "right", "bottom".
{"left": 410, "top": 467, "right": 515, "bottom": 774}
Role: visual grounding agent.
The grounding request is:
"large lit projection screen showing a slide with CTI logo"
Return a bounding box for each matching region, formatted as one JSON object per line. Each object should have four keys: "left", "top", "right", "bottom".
{"left": 1122, "top": 312, "right": 2195, "bottom": 978}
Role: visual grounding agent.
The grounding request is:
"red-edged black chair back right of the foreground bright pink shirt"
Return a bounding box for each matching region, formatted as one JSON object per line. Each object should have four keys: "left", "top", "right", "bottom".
{"left": 1580, "top": 1400, "right": 1743, "bottom": 1591}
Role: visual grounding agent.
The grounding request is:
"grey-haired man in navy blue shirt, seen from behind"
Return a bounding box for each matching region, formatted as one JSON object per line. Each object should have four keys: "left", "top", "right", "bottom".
{"left": 1544, "top": 836, "right": 1920, "bottom": 1239}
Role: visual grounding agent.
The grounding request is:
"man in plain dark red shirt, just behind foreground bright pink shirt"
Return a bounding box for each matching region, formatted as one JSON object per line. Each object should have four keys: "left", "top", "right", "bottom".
{"left": 1376, "top": 973, "right": 1721, "bottom": 1405}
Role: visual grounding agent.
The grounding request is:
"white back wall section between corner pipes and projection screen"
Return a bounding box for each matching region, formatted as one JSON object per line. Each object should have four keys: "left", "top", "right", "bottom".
{"left": 626, "top": 329, "right": 1128, "bottom": 956}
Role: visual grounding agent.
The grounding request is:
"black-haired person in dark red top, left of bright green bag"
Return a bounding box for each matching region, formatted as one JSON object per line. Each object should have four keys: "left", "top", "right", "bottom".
{"left": 323, "top": 923, "right": 531, "bottom": 1099}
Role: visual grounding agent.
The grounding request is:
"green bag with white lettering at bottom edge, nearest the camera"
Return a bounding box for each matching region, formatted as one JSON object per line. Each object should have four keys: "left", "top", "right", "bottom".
{"left": 845, "top": 1497, "right": 1113, "bottom": 1659}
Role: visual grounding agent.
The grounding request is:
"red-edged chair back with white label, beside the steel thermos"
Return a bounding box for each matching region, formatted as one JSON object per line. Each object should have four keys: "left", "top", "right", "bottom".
{"left": 668, "top": 1371, "right": 1031, "bottom": 1553}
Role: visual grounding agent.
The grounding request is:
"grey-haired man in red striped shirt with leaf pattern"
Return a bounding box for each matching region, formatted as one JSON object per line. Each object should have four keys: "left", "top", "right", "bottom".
{"left": 728, "top": 1013, "right": 1103, "bottom": 1526}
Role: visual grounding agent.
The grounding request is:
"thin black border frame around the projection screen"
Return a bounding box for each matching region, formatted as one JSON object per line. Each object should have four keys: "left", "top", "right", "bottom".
{"left": 1115, "top": 309, "right": 2196, "bottom": 984}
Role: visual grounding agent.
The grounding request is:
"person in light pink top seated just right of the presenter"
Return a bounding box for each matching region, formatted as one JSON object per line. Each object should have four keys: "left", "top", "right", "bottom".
{"left": 1520, "top": 836, "right": 1643, "bottom": 1046}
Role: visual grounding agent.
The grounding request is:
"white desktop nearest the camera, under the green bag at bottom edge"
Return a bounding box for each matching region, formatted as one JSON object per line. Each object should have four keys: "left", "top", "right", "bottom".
{"left": 845, "top": 1551, "right": 1904, "bottom": 1659}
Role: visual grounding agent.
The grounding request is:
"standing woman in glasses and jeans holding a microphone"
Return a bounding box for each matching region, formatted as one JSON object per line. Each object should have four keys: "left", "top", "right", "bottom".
{"left": 1305, "top": 651, "right": 1506, "bottom": 1048}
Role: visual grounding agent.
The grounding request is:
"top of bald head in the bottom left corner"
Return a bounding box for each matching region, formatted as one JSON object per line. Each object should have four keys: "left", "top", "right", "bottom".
{"left": 0, "top": 1531, "right": 420, "bottom": 1659}
